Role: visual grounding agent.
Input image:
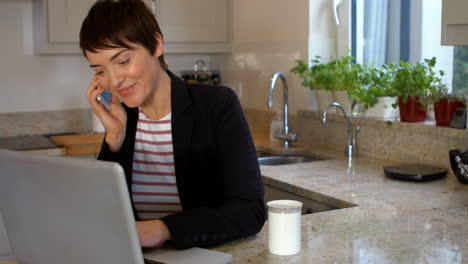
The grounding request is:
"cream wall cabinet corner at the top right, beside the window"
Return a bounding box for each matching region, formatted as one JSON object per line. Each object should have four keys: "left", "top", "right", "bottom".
{"left": 441, "top": 0, "right": 468, "bottom": 45}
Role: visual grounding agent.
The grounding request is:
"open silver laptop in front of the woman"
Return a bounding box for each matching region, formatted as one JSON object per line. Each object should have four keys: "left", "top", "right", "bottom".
{"left": 0, "top": 150, "right": 232, "bottom": 264}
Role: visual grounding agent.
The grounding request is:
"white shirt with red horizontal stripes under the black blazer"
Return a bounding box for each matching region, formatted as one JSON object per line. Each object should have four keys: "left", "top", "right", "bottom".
{"left": 132, "top": 109, "right": 182, "bottom": 220}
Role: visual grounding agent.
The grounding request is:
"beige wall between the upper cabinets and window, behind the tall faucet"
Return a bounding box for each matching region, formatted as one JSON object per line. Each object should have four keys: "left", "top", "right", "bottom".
{"left": 212, "top": 0, "right": 314, "bottom": 112}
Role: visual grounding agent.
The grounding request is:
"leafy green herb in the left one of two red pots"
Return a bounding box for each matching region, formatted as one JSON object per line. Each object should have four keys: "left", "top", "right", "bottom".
{"left": 391, "top": 57, "right": 442, "bottom": 122}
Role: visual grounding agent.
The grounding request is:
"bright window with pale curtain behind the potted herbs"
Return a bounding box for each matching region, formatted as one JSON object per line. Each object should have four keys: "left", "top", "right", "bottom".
{"left": 351, "top": 0, "right": 468, "bottom": 95}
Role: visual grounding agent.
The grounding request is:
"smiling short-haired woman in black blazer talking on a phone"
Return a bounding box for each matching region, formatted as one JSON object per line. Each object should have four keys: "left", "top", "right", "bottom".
{"left": 80, "top": 0, "right": 265, "bottom": 248}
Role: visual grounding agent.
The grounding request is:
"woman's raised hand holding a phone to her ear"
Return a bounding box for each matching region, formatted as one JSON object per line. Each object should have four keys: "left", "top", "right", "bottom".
{"left": 86, "top": 76, "right": 127, "bottom": 152}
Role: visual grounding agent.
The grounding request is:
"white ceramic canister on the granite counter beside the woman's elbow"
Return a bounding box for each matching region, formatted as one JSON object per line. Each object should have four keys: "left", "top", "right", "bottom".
{"left": 267, "top": 200, "right": 302, "bottom": 256}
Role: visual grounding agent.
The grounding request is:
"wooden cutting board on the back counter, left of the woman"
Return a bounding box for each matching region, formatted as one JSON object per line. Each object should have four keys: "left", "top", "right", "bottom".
{"left": 50, "top": 133, "right": 104, "bottom": 156}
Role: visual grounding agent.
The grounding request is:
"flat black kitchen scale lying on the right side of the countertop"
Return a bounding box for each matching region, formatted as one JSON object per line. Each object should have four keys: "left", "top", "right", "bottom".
{"left": 383, "top": 163, "right": 447, "bottom": 182}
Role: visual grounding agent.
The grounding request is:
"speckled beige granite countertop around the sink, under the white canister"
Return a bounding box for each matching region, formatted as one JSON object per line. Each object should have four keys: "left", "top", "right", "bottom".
{"left": 213, "top": 139, "right": 468, "bottom": 263}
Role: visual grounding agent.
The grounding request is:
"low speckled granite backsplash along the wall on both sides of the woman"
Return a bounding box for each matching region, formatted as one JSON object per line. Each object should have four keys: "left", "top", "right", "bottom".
{"left": 0, "top": 105, "right": 468, "bottom": 168}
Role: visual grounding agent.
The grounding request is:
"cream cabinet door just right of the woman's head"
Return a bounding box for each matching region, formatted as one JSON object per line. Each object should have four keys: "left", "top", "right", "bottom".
{"left": 153, "top": 0, "right": 231, "bottom": 53}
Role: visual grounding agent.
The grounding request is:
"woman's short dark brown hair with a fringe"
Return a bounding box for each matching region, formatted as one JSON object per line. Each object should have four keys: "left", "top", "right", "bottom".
{"left": 80, "top": 0, "right": 167, "bottom": 69}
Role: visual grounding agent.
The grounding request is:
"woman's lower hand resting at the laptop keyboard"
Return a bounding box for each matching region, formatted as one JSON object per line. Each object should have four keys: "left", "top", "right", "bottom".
{"left": 136, "top": 219, "right": 171, "bottom": 247}
